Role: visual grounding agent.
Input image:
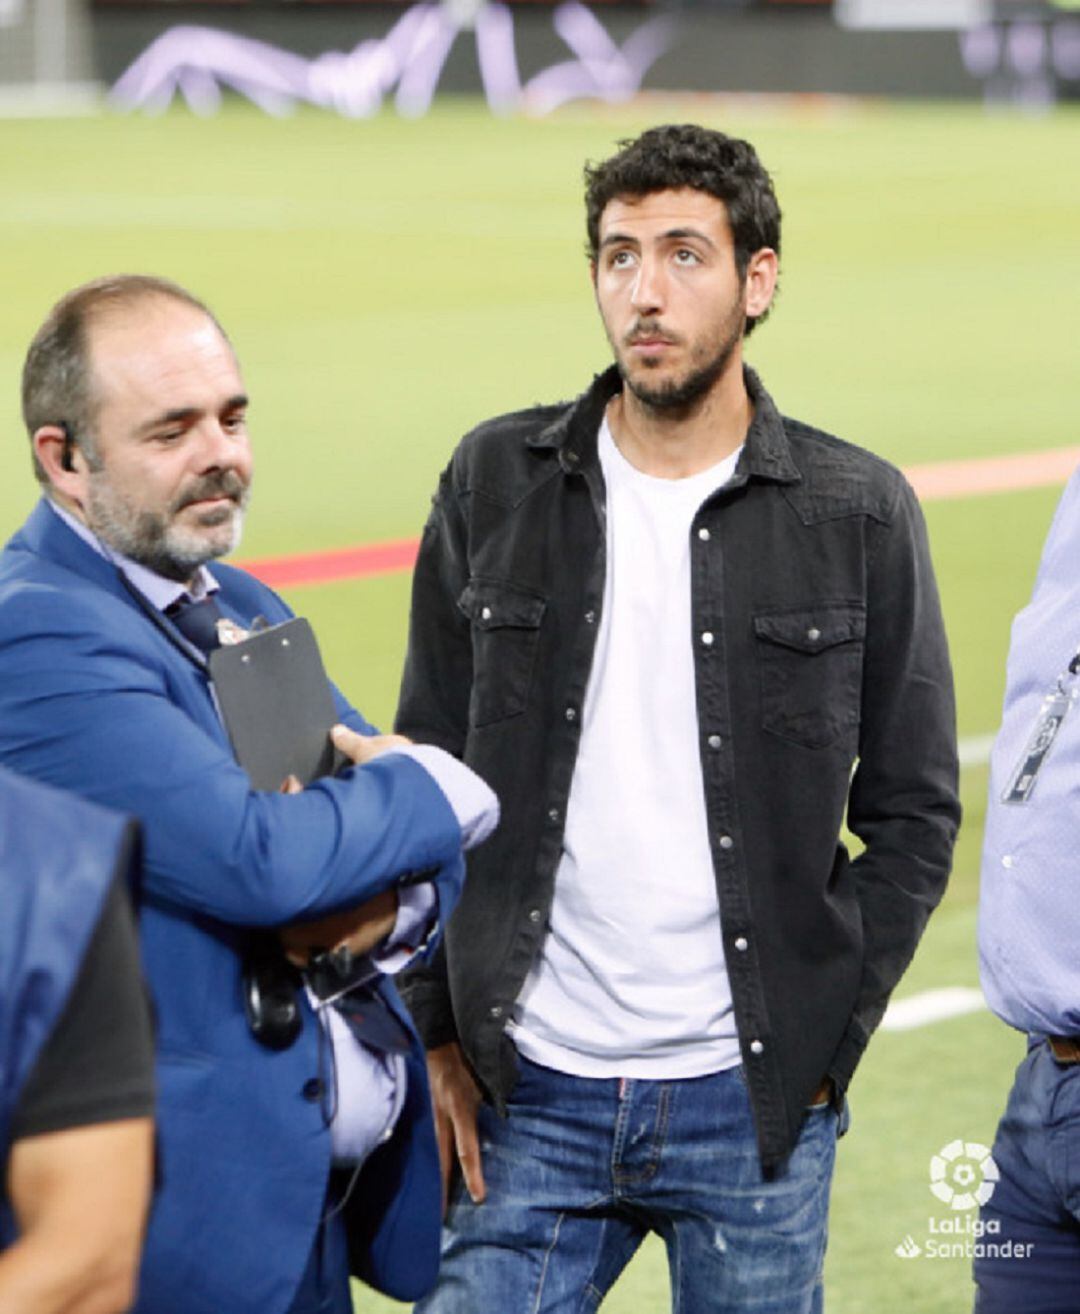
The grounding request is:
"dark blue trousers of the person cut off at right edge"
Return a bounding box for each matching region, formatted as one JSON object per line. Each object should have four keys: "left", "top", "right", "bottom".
{"left": 975, "top": 1041, "right": 1080, "bottom": 1314}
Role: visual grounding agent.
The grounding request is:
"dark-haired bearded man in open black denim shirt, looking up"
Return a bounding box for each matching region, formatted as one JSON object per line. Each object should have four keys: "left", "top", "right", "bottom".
{"left": 398, "top": 126, "right": 959, "bottom": 1314}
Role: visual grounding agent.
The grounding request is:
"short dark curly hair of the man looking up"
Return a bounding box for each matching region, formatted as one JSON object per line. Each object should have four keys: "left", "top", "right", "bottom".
{"left": 585, "top": 124, "right": 780, "bottom": 334}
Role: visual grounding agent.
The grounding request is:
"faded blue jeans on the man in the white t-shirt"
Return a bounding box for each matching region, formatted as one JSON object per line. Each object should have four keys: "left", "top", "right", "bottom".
{"left": 416, "top": 1059, "right": 837, "bottom": 1314}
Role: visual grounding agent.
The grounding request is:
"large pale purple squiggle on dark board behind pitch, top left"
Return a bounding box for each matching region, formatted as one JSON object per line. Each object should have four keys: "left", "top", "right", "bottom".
{"left": 105, "top": 0, "right": 671, "bottom": 118}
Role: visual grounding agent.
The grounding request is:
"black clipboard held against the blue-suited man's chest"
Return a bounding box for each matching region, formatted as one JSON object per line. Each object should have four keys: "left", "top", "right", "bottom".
{"left": 209, "top": 616, "right": 346, "bottom": 790}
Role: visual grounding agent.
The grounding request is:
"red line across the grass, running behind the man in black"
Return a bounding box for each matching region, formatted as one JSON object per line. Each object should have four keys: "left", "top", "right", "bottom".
{"left": 238, "top": 447, "right": 1080, "bottom": 589}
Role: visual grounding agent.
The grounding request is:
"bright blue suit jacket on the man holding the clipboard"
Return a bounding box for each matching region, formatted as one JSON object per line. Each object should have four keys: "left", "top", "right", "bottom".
{"left": 0, "top": 503, "right": 464, "bottom": 1314}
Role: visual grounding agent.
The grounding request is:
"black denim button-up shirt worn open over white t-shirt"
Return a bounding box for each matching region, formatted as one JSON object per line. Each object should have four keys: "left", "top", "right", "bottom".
{"left": 397, "top": 369, "right": 959, "bottom": 1169}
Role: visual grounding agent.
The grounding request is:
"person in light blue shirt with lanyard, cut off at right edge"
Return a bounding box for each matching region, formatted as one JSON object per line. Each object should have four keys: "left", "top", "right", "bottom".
{"left": 975, "top": 470, "right": 1080, "bottom": 1314}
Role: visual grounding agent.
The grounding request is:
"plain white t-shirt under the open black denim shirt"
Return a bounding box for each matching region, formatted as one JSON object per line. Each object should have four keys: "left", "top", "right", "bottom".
{"left": 511, "top": 420, "right": 740, "bottom": 1079}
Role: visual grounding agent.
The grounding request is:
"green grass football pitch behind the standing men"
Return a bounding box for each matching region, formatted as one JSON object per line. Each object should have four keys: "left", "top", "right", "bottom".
{"left": 0, "top": 99, "right": 1080, "bottom": 1314}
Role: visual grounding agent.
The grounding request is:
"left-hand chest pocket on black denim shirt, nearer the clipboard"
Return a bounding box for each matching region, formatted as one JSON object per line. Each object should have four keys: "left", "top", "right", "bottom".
{"left": 457, "top": 579, "right": 547, "bottom": 727}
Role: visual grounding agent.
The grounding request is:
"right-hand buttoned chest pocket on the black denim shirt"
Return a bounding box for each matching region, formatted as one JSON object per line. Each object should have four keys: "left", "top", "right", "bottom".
{"left": 754, "top": 603, "right": 866, "bottom": 748}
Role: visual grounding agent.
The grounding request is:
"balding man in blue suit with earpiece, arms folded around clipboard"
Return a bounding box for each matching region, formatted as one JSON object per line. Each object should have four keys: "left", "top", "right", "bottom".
{"left": 0, "top": 276, "right": 497, "bottom": 1314}
